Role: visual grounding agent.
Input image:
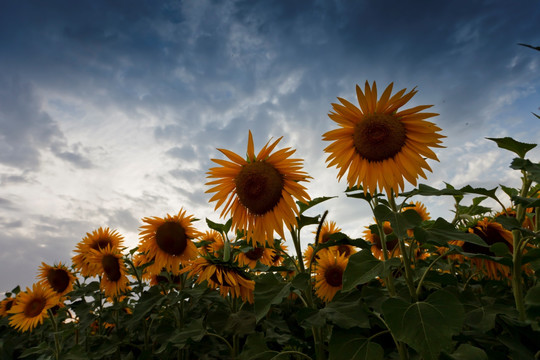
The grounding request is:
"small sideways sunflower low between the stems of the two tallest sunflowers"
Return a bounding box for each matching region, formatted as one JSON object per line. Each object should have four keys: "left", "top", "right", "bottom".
{"left": 315, "top": 251, "right": 348, "bottom": 302}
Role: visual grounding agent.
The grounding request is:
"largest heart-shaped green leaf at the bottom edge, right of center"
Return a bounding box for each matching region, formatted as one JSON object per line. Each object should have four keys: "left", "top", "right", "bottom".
{"left": 382, "top": 290, "right": 465, "bottom": 360}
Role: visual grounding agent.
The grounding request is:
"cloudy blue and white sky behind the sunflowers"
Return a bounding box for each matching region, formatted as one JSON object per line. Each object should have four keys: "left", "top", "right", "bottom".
{"left": 0, "top": 0, "right": 540, "bottom": 292}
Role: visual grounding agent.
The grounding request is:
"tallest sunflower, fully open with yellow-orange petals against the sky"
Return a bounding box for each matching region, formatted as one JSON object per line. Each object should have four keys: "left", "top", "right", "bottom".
{"left": 323, "top": 81, "right": 444, "bottom": 194}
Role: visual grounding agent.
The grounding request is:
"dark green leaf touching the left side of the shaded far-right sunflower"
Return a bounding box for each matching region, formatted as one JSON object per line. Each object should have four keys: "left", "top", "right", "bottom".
{"left": 414, "top": 218, "right": 488, "bottom": 247}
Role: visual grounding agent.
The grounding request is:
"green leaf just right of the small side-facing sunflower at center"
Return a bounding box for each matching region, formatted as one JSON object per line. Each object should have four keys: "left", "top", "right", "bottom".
{"left": 343, "top": 249, "right": 401, "bottom": 291}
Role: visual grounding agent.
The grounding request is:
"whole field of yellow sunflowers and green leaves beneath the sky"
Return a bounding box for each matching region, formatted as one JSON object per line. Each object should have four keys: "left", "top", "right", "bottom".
{"left": 0, "top": 82, "right": 540, "bottom": 360}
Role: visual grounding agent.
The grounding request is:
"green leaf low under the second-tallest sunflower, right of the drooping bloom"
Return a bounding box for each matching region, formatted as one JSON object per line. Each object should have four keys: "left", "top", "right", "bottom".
{"left": 253, "top": 273, "right": 291, "bottom": 322}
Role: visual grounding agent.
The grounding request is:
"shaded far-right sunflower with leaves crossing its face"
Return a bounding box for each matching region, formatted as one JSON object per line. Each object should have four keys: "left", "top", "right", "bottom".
{"left": 450, "top": 218, "right": 513, "bottom": 280}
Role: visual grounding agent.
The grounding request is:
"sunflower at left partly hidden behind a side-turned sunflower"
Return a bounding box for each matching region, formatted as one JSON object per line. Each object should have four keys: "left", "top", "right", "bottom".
{"left": 71, "top": 227, "right": 124, "bottom": 277}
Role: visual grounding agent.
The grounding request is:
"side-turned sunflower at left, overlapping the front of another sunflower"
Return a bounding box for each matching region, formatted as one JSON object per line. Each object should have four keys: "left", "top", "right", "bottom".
{"left": 90, "top": 246, "right": 129, "bottom": 298}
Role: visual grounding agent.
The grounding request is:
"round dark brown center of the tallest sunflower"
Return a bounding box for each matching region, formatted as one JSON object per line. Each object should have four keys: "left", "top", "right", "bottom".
{"left": 353, "top": 114, "right": 407, "bottom": 161}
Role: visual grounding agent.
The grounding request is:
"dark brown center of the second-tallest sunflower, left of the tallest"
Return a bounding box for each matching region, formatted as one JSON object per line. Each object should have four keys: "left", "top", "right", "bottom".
{"left": 234, "top": 161, "right": 283, "bottom": 215}
